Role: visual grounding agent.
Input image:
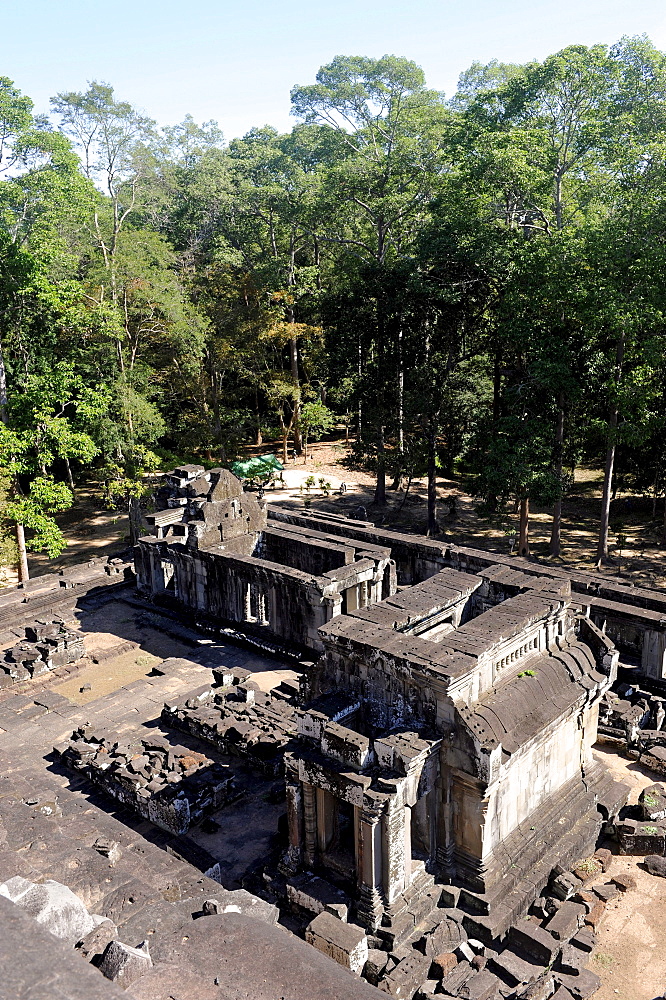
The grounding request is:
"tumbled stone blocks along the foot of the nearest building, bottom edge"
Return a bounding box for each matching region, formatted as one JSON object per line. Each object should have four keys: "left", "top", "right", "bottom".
{"left": 274, "top": 848, "right": 628, "bottom": 1000}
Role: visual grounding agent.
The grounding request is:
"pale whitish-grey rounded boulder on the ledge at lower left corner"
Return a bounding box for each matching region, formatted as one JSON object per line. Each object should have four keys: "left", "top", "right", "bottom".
{"left": 0, "top": 875, "right": 95, "bottom": 945}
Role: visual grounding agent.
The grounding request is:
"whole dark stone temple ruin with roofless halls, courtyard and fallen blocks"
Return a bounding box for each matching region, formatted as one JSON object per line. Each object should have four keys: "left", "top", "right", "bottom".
{"left": 0, "top": 466, "right": 666, "bottom": 1000}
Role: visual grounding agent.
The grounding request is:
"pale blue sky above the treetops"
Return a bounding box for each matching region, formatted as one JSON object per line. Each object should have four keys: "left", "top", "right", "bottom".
{"left": 5, "top": 0, "right": 666, "bottom": 139}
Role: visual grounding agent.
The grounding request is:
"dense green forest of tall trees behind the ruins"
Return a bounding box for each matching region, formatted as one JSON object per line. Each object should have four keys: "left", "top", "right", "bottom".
{"left": 0, "top": 37, "right": 666, "bottom": 579}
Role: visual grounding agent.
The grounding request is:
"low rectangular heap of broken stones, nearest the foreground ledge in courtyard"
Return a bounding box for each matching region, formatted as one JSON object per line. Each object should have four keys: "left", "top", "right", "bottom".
{"left": 54, "top": 726, "right": 239, "bottom": 835}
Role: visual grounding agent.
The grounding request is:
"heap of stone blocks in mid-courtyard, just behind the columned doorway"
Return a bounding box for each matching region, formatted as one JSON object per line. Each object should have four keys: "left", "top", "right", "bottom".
{"left": 162, "top": 667, "right": 300, "bottom": 776}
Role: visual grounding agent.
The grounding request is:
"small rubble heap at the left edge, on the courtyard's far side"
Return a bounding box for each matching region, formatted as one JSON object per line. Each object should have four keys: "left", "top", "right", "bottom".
{"left": 0, "top": 618, "right": 85, "bottom": 688}
